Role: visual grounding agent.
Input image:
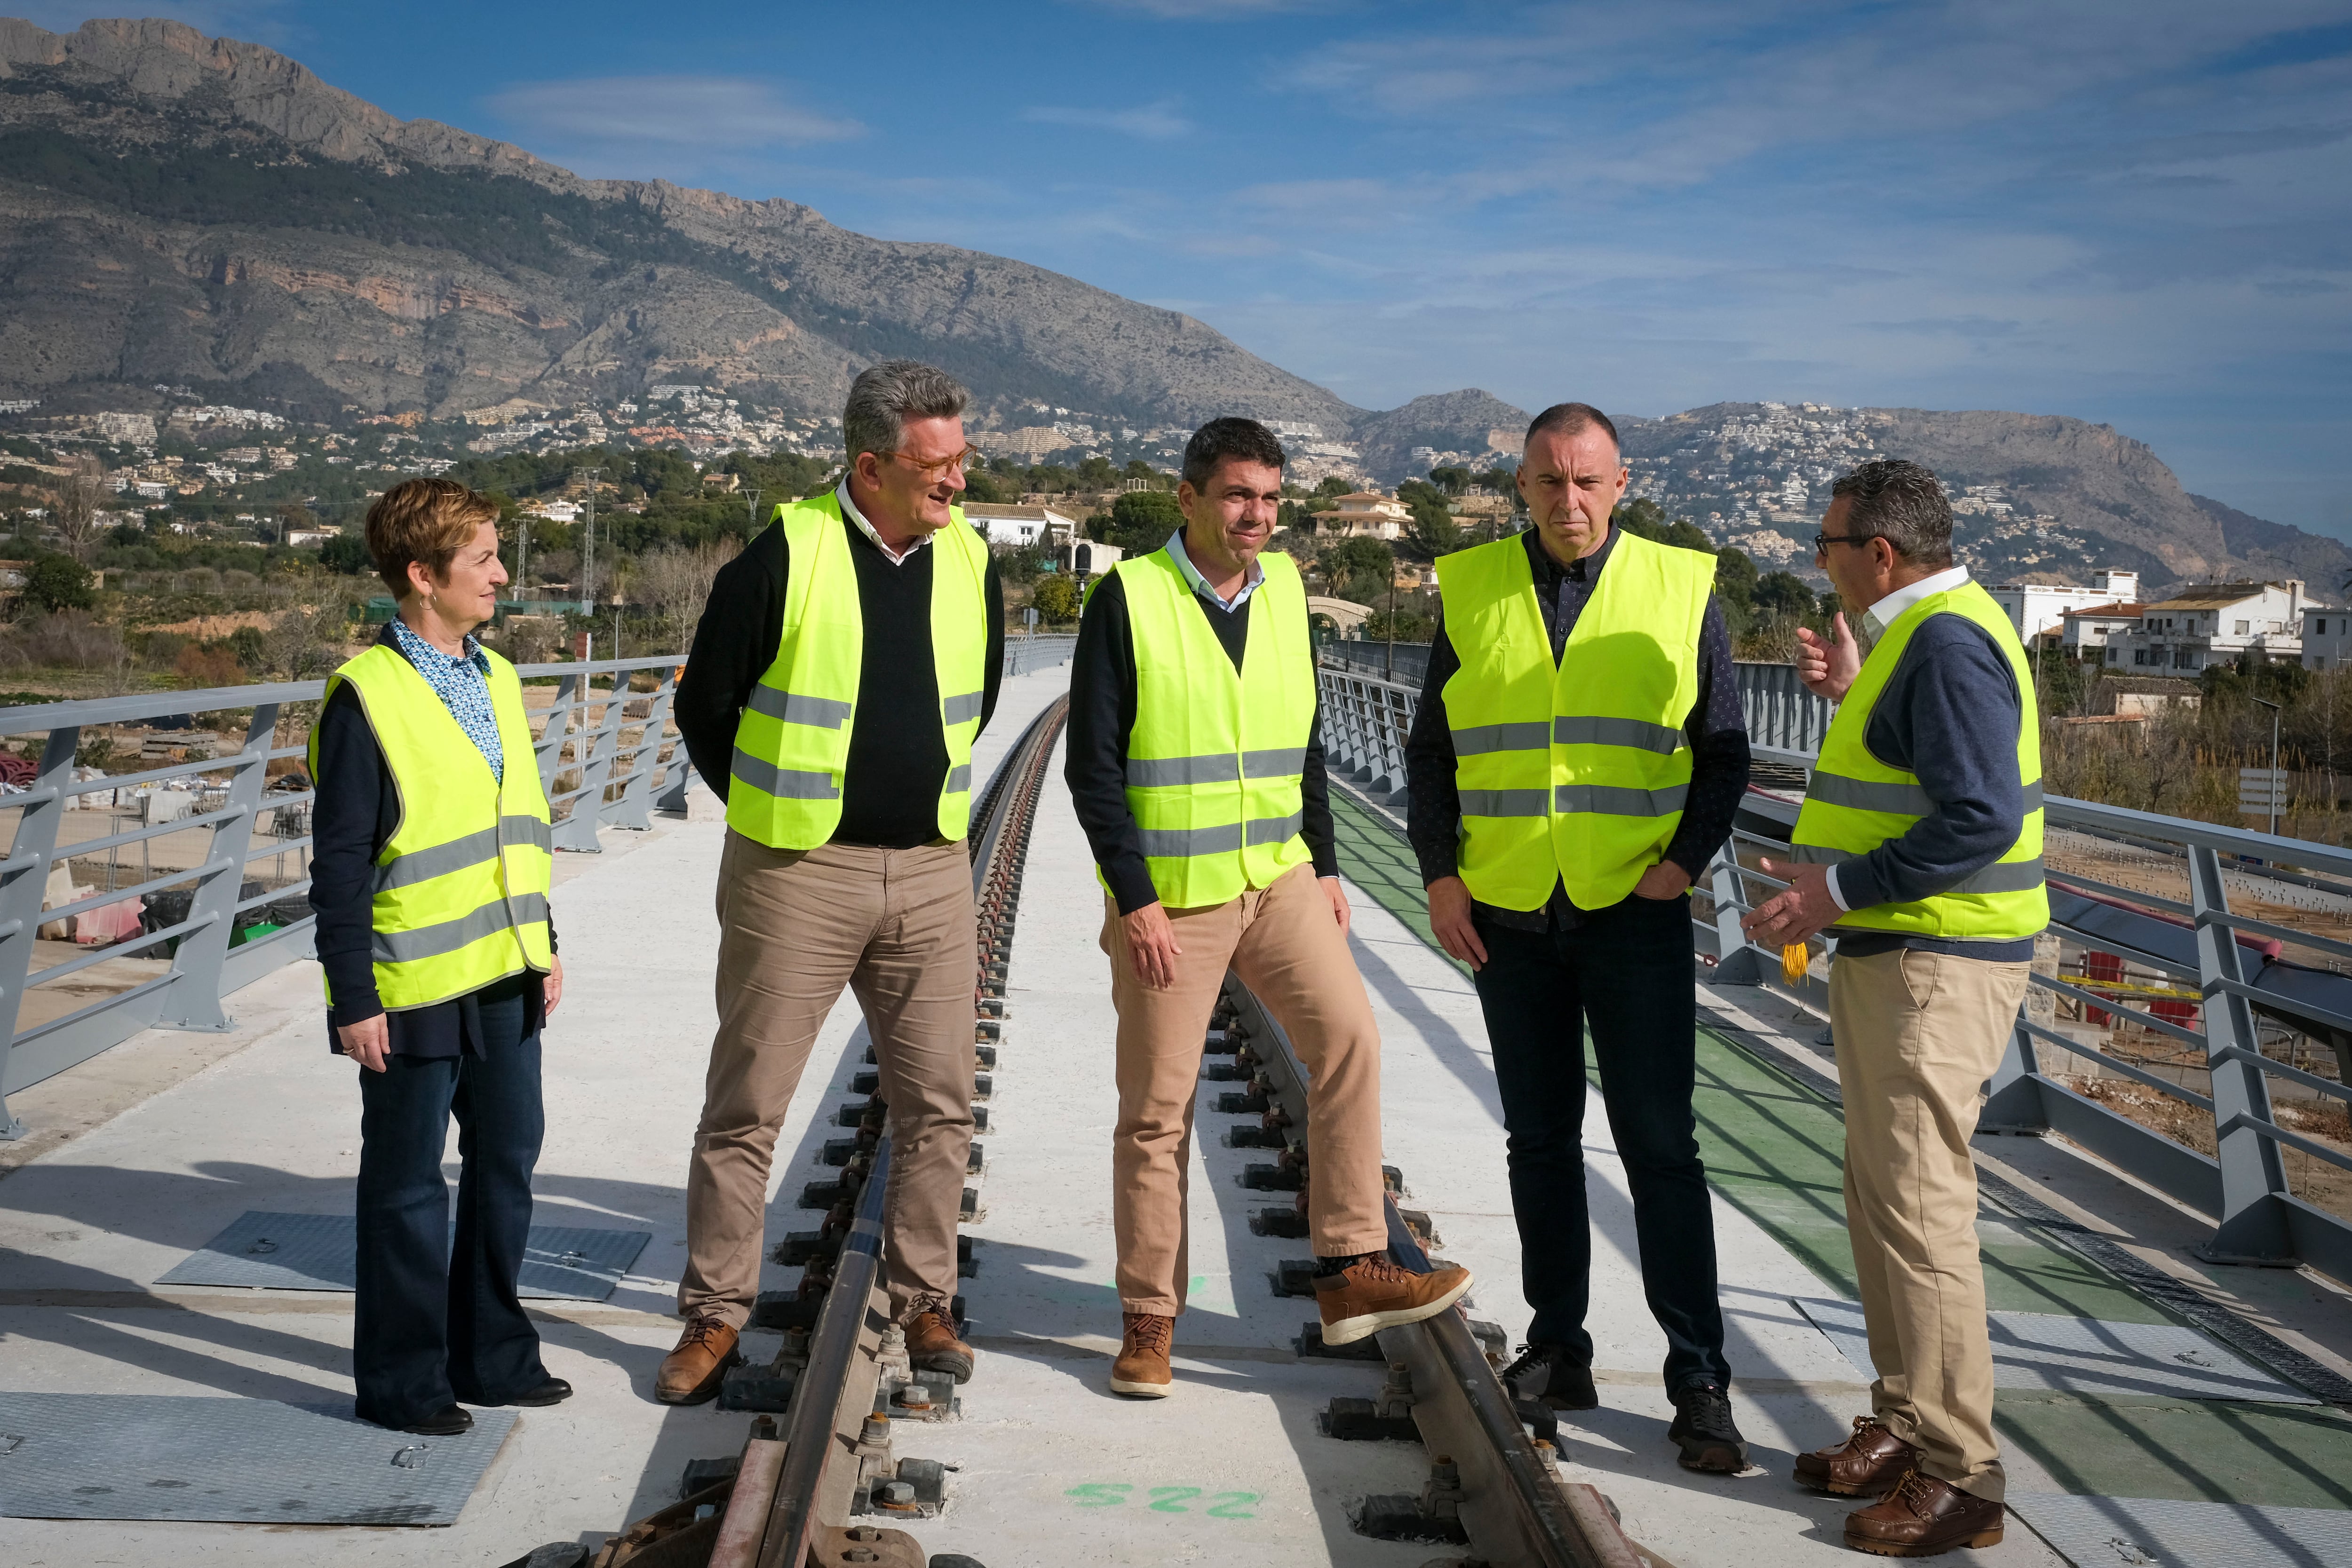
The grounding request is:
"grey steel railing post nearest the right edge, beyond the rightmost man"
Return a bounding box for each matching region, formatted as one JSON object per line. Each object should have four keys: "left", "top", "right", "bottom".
{"left": 2187, "top": 844, "right": 2296, "bottom": 1262}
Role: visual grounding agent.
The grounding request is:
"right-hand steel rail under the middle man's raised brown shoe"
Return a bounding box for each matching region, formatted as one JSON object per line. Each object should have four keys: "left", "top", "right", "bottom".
{"left": 1225, "top": 971, "right": 1646, "bottom": 1568}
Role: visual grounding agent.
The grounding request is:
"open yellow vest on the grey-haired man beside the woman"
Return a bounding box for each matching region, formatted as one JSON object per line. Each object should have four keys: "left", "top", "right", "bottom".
{"left": 727, "top": 494, "right": 988, "bottom": 848}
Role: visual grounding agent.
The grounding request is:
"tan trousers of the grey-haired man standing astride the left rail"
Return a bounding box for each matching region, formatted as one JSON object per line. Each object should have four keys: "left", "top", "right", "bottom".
{"left": 677, "top": 832, "right": 978, "bottom": 1328}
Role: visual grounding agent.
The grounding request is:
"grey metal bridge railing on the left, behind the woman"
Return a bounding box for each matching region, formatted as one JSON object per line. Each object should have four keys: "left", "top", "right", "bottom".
{"left": 0, "top": 656, "right": 691, "bottom": 1138}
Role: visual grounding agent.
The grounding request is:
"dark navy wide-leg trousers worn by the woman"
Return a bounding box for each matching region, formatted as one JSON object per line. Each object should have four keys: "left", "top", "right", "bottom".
{"left": 350, "top": 980, "right": 548, "bottom": 1427}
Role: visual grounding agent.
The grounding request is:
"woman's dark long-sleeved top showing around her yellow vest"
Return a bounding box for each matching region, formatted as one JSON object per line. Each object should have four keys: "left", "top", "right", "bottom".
{"left": 310, "top": 626, "right": 555, "bottom": 1055}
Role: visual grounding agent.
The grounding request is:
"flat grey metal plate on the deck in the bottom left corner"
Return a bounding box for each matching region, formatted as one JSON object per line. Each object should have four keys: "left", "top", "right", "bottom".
{"left": 0, "top": 1394, "right": 515, "bottom": 1526}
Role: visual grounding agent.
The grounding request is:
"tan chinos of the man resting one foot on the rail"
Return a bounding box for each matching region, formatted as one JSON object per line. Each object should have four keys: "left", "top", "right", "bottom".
{"left": 1103, "top": 865, "right": 1388, "bottom": 1316}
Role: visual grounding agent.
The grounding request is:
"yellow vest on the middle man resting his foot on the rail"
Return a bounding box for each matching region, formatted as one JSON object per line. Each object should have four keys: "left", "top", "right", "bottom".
{"left": 1112, "top": 550, "right": 1315, "bottom": 910}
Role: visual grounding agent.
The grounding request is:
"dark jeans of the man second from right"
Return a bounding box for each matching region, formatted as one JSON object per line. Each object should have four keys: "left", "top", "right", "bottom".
{"left": 1477, "top": 898, "right": 1731, "bottom": 1389}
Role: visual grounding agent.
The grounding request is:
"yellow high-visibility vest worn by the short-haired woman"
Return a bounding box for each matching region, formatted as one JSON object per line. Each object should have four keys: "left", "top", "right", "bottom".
{"left": 310, "top": 644, "right": 555, "bottom": 1013}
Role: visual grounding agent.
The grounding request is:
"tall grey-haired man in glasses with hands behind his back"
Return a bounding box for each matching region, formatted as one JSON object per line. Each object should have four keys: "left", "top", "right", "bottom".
{"left": 654, "top": 360, "right": 1004, "bottom": 1403}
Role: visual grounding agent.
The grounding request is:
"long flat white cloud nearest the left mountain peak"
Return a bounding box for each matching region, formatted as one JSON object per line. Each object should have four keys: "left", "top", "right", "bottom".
{"left": 482, "top": 75, "right": 866, "bottom": 153}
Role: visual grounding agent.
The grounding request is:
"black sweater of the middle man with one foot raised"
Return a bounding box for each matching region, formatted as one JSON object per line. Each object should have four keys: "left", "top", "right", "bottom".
{"left": 1063, "top": 574, "right": 1338, "bottom": 914}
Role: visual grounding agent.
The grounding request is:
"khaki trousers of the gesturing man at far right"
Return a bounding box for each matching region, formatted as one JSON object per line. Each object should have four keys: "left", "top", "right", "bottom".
{"left": 1830, "top": 950, "right": 2032, "bottom": 1502}
